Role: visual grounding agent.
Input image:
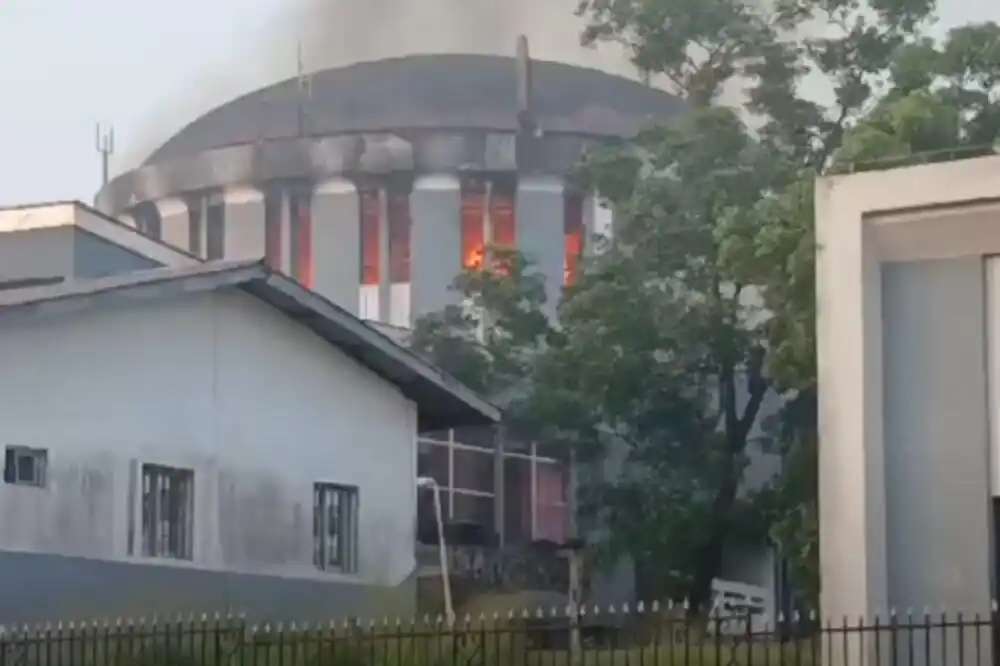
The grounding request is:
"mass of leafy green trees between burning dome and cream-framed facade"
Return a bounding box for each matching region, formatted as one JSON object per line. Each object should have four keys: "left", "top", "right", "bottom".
{"left": 415, "top": 0, "right": 1000, "bottom": 608}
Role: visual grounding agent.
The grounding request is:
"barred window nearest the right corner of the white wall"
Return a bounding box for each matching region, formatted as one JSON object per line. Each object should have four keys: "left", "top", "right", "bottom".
{"left": 313, "top": 483, "right": 358, "bottom": 573}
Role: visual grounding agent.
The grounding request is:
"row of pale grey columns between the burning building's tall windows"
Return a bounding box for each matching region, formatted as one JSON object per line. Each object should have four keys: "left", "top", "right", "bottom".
{"left": 122, "top": 174, "right": 610, "bottom": 326}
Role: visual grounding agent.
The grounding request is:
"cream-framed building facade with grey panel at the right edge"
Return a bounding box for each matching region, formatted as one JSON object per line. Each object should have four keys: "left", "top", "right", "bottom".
{"left": 816, "top": 156, "right": 1000, "bottom": 664}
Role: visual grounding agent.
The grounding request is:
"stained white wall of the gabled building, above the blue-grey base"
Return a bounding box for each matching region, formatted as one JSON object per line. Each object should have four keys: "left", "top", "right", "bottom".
{"left": 0, "top": 292, "right": 416, "bottom": 585}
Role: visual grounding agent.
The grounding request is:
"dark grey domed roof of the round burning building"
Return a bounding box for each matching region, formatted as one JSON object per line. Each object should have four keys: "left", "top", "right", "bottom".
{"left": 146, "top": 55, "right": 682, "bottom": 164}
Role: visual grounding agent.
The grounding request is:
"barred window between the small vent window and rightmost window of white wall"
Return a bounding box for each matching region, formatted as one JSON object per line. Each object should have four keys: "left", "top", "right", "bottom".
{"left": 142, "top": 464, "right": 194, "bottom": 560}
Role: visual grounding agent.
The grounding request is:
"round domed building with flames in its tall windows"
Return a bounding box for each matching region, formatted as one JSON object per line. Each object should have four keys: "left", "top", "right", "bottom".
{"left": 97, "top": 39, "right": 681, "bottom": 327}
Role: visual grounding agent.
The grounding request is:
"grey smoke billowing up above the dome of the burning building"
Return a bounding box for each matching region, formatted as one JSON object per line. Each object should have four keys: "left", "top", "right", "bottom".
{"left": 117, "top": 0, "right": 636, "bottom": 170}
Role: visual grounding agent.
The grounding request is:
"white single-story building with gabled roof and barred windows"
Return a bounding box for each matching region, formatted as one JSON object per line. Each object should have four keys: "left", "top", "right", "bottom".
{"left": 0, "top": 262, "right": 499, "bottom": 623}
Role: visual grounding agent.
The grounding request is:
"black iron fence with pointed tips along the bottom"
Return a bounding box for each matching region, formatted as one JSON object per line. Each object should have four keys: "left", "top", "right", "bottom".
{"left": 0, "top": 607, "right": 1000, "bottom": 666}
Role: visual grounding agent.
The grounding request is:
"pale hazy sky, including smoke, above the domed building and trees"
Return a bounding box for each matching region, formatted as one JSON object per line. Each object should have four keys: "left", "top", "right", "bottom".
{"left": 0, "top": 0, "right": 1000, "bottom": 206}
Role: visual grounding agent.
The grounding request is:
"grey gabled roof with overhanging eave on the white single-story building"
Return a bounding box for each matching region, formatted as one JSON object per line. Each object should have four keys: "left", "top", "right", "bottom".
{"left": 0, "top": 261, "right": 500, "bottom": 431}
